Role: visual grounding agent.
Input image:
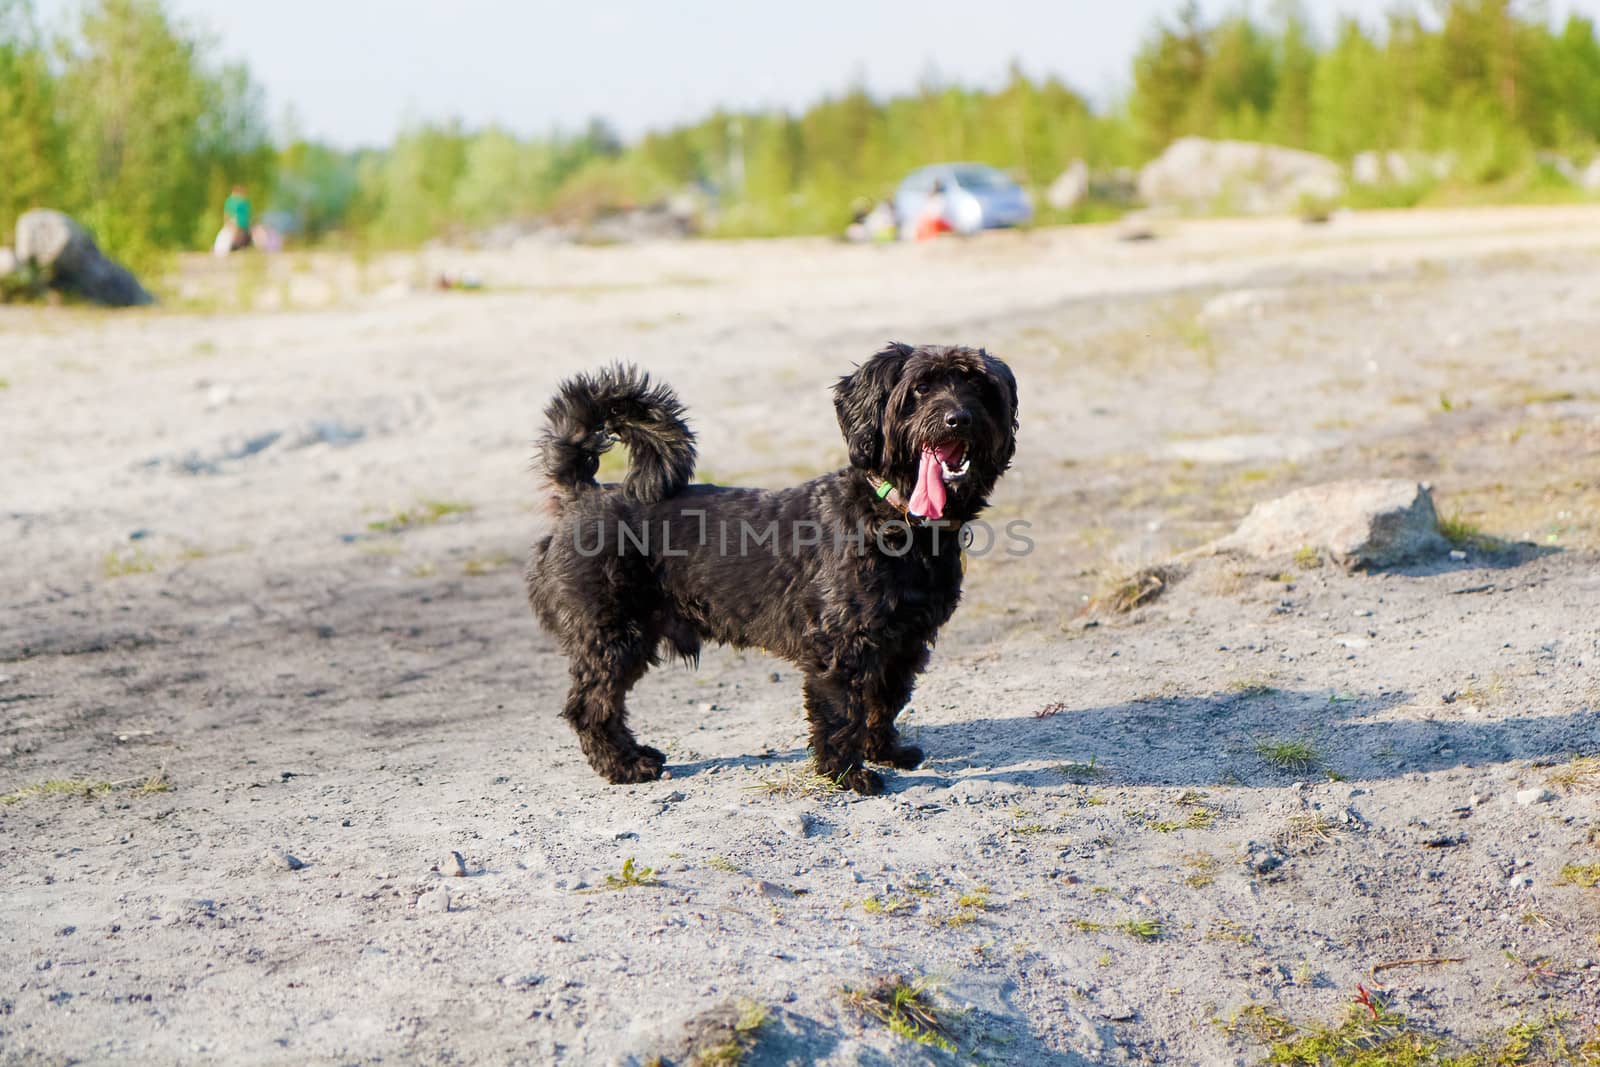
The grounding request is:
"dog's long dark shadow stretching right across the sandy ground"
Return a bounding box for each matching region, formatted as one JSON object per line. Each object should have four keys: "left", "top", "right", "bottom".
{"left": 670, "top": 689, "right": 1600, "bottom": 792}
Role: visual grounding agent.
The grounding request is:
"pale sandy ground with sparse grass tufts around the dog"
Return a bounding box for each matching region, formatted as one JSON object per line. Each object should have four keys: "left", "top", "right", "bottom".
{"left": 0, "top": 208, "right": 1600, "bottom": 1065}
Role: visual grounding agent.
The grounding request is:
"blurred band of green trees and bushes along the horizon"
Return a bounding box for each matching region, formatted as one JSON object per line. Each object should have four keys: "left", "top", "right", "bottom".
{"left": 0, "top": 0, "right": 1600, "bottom": 259}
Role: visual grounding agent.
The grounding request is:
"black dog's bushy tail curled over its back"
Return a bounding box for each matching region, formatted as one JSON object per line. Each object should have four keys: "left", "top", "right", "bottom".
{"left": 536, "top": 363, "right": 694, "bottom": 509}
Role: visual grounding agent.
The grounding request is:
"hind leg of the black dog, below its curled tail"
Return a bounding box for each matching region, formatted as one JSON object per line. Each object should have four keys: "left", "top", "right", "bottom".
{"left": 562, "top": 638, "right": 667, "bottom": 785}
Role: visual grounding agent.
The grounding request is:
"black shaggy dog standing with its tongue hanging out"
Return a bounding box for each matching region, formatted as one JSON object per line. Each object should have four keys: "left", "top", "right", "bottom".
{"left": 528, "top": 344, "right": 1018, "bottom": 793}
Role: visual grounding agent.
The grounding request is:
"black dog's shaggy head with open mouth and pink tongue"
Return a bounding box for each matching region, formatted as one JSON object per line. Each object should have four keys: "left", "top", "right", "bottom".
{"left": 834, "top": 344, "right": 1016, "bottom": 522}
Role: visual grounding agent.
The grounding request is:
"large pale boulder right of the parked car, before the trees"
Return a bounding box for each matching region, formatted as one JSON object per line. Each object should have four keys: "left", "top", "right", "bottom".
{"left": 1139, "top": 138, "right": 1344, "bottom": 214}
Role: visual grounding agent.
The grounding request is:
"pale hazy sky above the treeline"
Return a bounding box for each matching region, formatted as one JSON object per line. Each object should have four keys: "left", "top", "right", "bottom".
{"left": 37, "top": 0, "right": 1600, "bottom": 147}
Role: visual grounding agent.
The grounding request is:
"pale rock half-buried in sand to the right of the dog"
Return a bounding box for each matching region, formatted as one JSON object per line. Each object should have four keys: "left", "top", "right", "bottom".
{"left": 1211, "top": 478, "right": 1450, "bottom": 568}
